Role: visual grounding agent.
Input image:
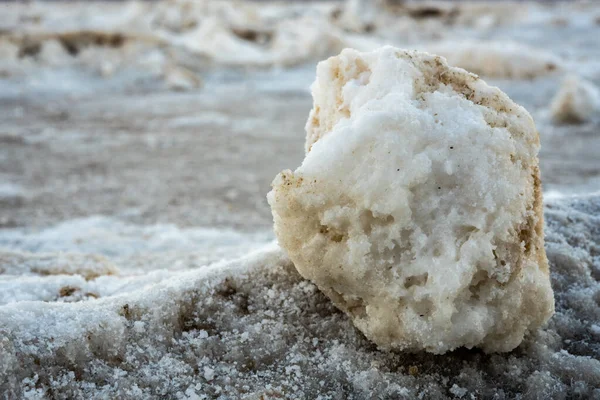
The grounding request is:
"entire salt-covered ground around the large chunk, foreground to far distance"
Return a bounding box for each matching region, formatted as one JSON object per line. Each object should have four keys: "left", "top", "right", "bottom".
{"left": 0, "top": 2, "right": 600, "bottom": 399}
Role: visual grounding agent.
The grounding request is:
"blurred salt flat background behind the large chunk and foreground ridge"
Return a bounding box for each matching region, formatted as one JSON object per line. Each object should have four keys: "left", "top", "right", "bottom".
{"left": 0, "top": 0, "right": 600, "bottom": 301}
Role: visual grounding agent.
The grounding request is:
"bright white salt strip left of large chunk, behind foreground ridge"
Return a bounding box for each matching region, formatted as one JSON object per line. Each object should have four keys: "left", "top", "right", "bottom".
{"left": 0, "top": 216, "right": 272, "bottom": 270}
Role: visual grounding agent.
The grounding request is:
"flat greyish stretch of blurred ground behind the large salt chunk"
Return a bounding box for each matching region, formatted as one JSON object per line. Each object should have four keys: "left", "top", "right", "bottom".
{"left": 0, "top": 74, "right": 600, "bottom": 231}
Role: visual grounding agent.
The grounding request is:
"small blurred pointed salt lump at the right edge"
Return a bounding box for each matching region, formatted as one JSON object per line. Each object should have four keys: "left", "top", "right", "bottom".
{"left": 550, "top": 76, "right": 600, "bottom": 123}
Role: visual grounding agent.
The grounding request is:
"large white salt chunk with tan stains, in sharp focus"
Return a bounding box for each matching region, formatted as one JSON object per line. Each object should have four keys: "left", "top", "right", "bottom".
{"left": 268, "top": 47, "right": 554, "bottom": 353}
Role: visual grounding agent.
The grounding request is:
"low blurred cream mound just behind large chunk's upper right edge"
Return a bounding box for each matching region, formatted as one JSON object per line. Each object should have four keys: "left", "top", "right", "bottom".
{"left": 424, "top": 41, "right": 562, "bottom": 79}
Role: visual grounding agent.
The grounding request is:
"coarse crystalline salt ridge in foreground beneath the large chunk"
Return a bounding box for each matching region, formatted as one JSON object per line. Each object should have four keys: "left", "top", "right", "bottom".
{"left": 0, "top": 195, "right": 600, "bottom": 399}
